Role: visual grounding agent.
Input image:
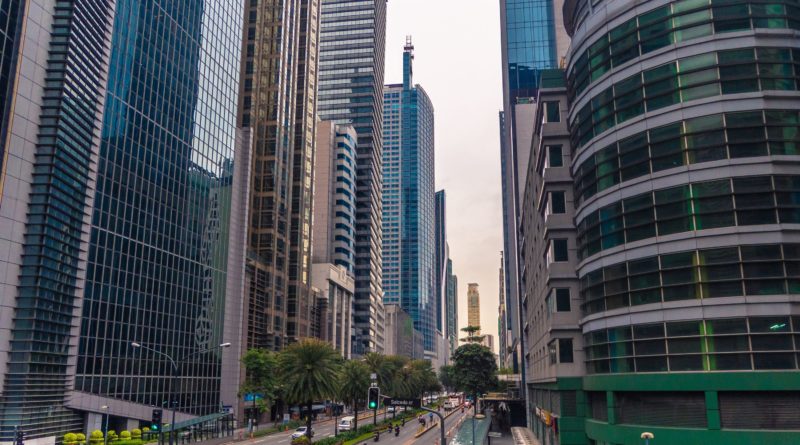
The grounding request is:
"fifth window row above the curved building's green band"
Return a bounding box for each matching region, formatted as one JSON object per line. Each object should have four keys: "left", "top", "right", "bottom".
{"left": 570, "top": 48, "right": 800, "bottom": 147}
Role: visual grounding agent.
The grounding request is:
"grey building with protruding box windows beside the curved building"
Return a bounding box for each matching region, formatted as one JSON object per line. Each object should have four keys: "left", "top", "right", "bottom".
{"left": 519, "top": 70, "right": 586, "bottom": 443}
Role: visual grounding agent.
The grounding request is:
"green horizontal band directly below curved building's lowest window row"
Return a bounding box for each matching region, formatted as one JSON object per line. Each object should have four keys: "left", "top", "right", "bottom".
{"left": 583, "top": 371, "right": 800, "bottom": 391}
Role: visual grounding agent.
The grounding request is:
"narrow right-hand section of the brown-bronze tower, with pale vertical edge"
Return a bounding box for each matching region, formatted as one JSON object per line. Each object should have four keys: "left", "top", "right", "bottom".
{"left": 286, "top": 0, "right": 320, "bottom": 341}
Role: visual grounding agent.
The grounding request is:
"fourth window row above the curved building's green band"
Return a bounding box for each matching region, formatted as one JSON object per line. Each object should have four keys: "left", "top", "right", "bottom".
{"left": 575, "top": 110, "right": 800, "bottom": 200}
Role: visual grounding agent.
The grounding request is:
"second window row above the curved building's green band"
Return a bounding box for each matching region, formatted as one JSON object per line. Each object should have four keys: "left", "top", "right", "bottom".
{"left": 580, "top": 244, "right": 800, "bottom": 315}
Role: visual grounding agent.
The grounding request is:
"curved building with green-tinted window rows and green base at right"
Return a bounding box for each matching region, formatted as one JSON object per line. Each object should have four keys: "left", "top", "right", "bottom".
{"left": 564, "top": 0, "right": 800, "bottom": 444}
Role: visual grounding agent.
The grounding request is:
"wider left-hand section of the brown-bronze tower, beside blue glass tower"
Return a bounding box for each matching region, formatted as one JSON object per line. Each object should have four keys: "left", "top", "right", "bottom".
{"left": 239, "top": 0, "right": 300, "bottom": 350}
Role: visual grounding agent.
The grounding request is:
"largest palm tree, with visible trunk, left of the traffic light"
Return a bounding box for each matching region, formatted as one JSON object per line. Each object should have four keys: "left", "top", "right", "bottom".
{"left": 279, "top": 338, "right": 340, "bottom": 439}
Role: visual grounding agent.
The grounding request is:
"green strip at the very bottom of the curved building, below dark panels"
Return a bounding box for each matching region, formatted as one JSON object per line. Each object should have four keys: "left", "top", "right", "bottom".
{"left": 586, "top": 420, "right": 800, "bottom": 445}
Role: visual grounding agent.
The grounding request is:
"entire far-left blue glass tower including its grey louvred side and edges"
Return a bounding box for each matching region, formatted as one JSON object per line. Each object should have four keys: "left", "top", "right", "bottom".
{"left": 0, "top": 0, "right": 247, "bottom": 443}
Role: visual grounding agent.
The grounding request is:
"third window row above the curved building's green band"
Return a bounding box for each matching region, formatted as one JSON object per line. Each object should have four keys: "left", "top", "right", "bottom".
{"left": 577, "top": 176, "right": 800, "bottom": 259}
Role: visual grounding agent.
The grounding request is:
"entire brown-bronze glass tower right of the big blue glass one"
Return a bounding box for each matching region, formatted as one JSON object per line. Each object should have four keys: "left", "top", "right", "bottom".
{"left": 239, "top": 0, "right": 319, "bottom": 350}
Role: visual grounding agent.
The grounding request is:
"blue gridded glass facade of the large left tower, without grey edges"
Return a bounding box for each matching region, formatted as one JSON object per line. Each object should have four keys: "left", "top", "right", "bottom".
{"left": 75, "top": 0, "right": 242, "bottom": 415}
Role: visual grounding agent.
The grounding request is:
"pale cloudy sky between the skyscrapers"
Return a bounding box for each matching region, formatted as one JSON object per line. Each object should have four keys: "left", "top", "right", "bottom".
{"left": 385, "top": 0, "right": 503, "bottom": 346}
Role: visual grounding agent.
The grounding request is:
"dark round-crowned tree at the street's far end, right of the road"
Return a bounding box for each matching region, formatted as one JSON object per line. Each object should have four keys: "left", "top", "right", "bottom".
{"left": 453, "top": 343, "right": 497, "bottom": 410}
